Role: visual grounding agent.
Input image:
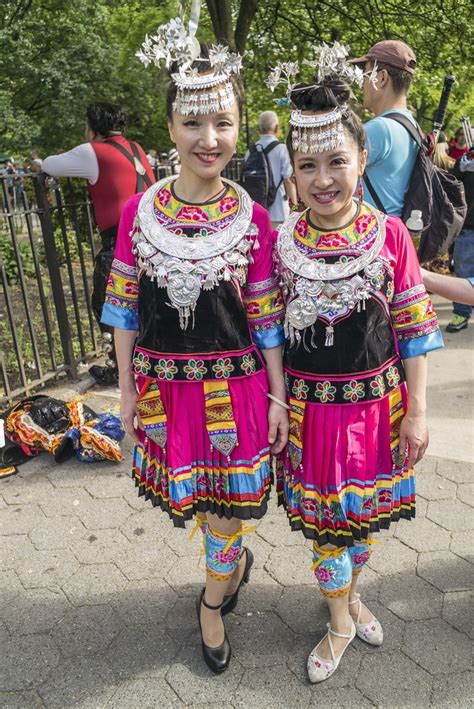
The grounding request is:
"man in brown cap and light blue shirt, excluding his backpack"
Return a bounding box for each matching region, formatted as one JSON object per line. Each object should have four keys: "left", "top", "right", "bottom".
{"left": 351, "top": 39, "right": 418, "bottom": 217}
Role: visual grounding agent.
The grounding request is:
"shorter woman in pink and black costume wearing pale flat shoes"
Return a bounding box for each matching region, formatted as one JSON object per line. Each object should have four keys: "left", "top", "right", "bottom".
{"left": 269, "top": 43, "right": 443, "bottom": 682}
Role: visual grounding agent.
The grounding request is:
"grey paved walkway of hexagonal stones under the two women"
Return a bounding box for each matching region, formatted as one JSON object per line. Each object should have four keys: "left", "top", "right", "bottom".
{"left": 0, "top": 298, "right": 474, "bottom": 709}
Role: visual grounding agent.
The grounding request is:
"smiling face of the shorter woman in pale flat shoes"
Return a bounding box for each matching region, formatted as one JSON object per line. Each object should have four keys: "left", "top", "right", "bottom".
{"left": 293, "top": 130, "right": 367, "bottom": 229}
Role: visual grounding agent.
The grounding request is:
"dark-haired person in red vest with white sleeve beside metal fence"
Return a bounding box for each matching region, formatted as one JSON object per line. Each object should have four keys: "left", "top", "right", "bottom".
{"left": 43, "top": 103, "right": 155, "bottom": 386}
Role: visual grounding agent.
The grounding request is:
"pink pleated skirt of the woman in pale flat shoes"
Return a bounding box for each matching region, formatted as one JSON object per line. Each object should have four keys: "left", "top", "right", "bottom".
{"left": 277, "top": 384, "right": 415, "bottom": 547}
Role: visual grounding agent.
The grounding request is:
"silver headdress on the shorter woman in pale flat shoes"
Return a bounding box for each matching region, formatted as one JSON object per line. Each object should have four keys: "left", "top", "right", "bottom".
{"left": 266, "top": 42, "right": 377, "bottom": 153}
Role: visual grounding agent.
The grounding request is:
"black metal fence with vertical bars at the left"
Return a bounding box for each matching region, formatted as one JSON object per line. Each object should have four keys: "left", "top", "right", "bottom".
{"left": 0, "top": 158, "right": 242, "bottom": 407}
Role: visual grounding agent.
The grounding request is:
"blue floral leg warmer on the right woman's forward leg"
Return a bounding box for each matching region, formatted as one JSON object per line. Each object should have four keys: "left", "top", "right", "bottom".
{"left": 311, "top": 542, "right": 352, "bottom": 598}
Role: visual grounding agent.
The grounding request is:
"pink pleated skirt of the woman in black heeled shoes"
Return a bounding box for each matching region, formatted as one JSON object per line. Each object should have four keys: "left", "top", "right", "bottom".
{"left": 133, "top": 370, "right": 271, "bottom": 527}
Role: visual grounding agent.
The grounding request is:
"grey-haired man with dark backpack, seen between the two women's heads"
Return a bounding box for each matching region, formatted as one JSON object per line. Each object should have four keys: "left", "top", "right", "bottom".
{"left": 239, "top": 111, "right": 296, "bottom": 227}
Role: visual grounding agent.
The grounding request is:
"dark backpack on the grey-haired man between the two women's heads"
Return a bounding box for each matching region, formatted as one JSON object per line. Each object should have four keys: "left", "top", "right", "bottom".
{"left": 239, "top": 140, "right": 283, "bottom": 209}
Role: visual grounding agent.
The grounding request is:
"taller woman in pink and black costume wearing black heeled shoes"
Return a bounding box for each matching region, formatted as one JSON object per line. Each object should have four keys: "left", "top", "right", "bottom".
{"left": 102, "top": 13, "right": 288, "bottom": 672}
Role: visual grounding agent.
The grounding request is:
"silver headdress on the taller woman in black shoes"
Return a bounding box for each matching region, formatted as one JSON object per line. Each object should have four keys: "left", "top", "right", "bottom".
{"left": 136, "top": 0, "right": 242, "bottom": 116}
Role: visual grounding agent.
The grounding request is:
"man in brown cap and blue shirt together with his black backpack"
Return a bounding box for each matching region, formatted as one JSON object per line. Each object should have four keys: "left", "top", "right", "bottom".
{"left": 351, "top": 40, "right": 467, "bottom": 261}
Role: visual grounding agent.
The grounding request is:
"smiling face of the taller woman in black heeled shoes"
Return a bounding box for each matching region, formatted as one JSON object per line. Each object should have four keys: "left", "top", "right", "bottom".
{"left": 168, "top": 93, "right": 240, "bottom": 179}
